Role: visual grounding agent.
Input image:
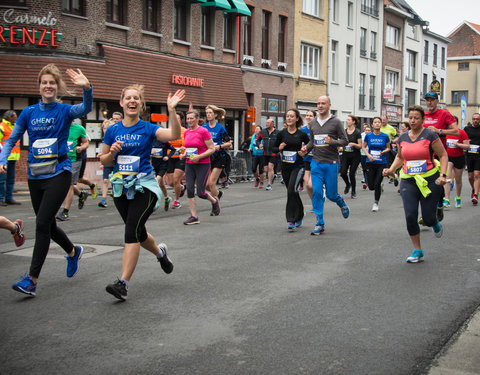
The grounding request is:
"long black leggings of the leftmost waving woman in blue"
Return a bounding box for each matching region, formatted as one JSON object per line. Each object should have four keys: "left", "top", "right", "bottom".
{"left": 28, "top": 171, "right": 73, "bottom": 278}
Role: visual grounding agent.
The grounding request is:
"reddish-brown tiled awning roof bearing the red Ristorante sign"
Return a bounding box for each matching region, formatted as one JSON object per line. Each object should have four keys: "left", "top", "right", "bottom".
{"left": 0, "top": 45, "right": 248, "bottom": 109}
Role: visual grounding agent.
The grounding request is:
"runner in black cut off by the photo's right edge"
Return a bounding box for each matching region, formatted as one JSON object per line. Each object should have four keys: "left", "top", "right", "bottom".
{"left": 465, "top": 113, "right": 480, "bottom": 206}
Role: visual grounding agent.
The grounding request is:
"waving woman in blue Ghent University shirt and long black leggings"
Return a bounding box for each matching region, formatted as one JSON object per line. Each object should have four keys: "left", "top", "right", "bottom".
{"left": 0, "top": 64, "right": 93, "bottom": 296}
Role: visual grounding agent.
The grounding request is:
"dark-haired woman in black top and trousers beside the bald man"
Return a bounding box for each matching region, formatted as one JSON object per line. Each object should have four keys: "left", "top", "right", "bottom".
{"left": 273, "top": 109, "right": 310, "bottom": 231}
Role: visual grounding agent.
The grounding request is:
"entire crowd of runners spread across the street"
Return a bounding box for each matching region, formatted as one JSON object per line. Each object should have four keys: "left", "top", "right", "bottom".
{"left": 0, "top": 64, "right": 480, "bottom": 300}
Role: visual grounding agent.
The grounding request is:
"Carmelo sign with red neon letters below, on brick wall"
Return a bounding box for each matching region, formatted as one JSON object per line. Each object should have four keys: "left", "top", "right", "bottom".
{"left": 0, "top": 9, "right": 62, "bottom": 47}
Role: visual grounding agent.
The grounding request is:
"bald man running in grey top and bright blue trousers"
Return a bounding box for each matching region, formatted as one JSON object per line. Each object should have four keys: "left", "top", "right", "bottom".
{"left": 302, "top": 96, "right": 350, "bottom": 236}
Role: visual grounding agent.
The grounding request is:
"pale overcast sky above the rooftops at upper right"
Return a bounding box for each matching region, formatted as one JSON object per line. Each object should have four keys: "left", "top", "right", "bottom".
{"left": 406, "top": 0, "right": 480, "bottom": 36}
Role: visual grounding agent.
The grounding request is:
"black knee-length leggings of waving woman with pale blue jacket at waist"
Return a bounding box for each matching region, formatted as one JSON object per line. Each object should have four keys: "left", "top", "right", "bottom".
{"left": 113, "top": 189, "right": 157, "bottom": 243}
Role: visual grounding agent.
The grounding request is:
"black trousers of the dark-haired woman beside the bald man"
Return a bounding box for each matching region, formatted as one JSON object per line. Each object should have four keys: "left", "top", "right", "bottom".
{"left": 282, "top": 163, "right": 305, "bottom": 223}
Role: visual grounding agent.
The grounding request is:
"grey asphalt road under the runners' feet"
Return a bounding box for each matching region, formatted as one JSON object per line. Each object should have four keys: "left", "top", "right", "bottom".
{"left": 0, "top": 178, "right": 480, "bottom": 375}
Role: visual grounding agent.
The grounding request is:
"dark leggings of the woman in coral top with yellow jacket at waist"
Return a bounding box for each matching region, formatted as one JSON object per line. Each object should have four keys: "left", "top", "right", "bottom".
{"left": 400, "top": 173, "right": 443, "bottom": 236}
